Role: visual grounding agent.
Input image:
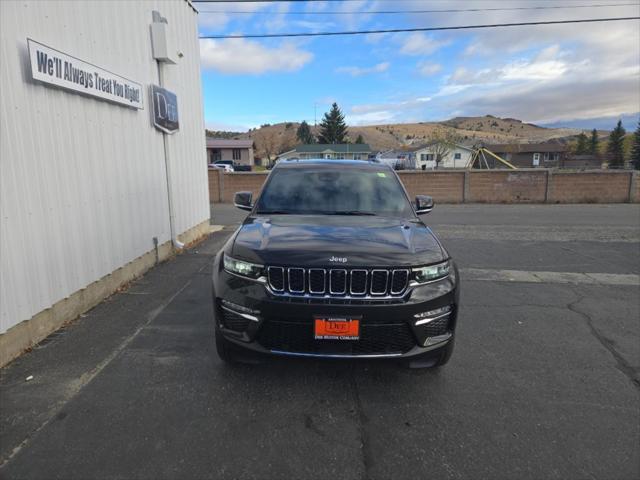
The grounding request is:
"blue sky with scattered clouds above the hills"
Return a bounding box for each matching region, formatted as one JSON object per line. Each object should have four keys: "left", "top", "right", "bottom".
{"left": 195, "top": 0, "right": 640, "bottom": 130}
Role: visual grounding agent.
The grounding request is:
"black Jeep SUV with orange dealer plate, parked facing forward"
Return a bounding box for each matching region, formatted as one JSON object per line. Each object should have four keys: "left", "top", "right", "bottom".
{"left": 213, "top": 160, "right": 459, "bottom": 367}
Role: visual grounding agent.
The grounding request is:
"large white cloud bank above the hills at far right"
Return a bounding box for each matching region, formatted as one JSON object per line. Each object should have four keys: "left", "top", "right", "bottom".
{"left": 435, "top": 40, "right": 640, "bottom": 123}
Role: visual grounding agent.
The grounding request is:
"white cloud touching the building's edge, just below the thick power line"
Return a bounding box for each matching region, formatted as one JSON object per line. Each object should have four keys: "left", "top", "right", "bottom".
{"left": 200, "top": 38, "right": 313, "bottom": 75}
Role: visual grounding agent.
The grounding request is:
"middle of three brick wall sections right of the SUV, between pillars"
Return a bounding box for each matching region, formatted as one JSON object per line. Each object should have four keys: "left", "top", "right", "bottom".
{"left": 466, "top": 170, "right": 547, "bottom": 203}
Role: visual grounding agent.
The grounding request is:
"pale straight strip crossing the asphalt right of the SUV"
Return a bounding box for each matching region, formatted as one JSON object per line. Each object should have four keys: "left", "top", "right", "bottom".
{"left": 460, "top": 268, "right": 640, "bottom": 286}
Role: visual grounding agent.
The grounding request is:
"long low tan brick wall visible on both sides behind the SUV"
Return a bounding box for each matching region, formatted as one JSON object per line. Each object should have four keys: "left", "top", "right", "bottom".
{"left": 209, "top": 169, "right": 640, "bottom": 203}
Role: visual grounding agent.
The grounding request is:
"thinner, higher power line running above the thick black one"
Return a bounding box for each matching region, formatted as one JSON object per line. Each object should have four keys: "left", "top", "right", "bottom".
{"left": 199, "top": 3, "right": 639, "bottom": 15}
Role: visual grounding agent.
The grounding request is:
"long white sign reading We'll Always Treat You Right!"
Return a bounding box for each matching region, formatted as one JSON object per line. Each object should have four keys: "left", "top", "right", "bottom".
{"left": 27, "top": 38, "right": 144, "bottom": 109}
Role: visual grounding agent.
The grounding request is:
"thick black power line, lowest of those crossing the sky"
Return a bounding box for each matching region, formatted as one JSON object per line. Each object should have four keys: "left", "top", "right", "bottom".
{"left": 200, "top": 16, "right": 640, "bottom": 39}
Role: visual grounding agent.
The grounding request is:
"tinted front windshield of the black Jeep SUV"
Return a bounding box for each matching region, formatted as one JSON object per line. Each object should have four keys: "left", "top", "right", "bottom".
{"left": 252, "top": 166, "right": 412, "bottom": 216}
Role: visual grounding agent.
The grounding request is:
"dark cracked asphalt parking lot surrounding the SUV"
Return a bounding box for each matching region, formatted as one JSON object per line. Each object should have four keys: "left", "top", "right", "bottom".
{"left": 0, "top": 205, "right": 640, "bottom": 479}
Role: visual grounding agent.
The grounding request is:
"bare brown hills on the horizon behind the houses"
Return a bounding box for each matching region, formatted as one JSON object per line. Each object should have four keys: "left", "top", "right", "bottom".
{"left": 221, "top": 115, "right": 580, "bottom": 157}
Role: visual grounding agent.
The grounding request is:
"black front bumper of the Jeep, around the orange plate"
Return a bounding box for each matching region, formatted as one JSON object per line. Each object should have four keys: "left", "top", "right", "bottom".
{"left": 213, "top": 262, "right": 459, "bottom": 358}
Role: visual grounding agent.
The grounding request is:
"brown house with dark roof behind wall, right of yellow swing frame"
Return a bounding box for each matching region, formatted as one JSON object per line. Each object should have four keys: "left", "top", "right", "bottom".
{"left": 486, "top": 142, "right": 567, "bottom": 168}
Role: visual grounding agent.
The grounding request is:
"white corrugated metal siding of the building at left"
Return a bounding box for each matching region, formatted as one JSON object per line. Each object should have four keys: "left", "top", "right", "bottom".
{"left": 0, "top": 0, "right": 209, "bottom": 333}
